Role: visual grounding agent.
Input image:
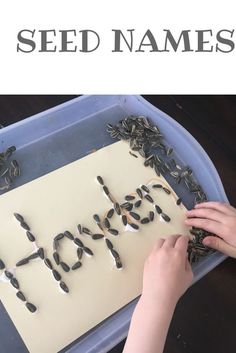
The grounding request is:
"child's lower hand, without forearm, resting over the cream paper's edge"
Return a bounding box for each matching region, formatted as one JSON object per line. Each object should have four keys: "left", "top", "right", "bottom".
{"left": 142, "top": 235, "right": 193, "bottom": 305}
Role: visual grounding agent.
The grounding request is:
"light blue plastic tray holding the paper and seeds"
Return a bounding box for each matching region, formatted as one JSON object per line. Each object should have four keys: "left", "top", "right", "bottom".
{"left": 0, "top": 95, "right": 227, "bottom": 353}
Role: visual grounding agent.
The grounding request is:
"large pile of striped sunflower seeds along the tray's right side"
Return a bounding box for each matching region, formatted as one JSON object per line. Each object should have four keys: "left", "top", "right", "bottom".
{"left": 107, "top": 116, "right": 213, "bottom": 263}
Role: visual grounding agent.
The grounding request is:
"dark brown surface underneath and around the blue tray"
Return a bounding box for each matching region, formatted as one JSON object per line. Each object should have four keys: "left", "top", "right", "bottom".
{"left": 0, "top": 96, "right": 236, "bottom": 353}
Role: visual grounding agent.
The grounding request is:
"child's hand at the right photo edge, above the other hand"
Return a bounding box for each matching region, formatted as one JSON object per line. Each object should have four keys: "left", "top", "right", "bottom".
{"left": 185, "top": 202, "right": 236, "bottom": 258}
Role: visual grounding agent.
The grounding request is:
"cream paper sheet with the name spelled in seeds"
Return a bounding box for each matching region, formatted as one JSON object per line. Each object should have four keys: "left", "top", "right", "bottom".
{"left": 0, "top": 142, "right": 188, "bottom": 353}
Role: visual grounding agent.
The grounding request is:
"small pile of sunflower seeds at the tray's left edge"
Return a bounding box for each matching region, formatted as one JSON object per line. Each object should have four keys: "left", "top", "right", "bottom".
{"left": 0, "top": 146, "right": 20, "bottom": 191}
